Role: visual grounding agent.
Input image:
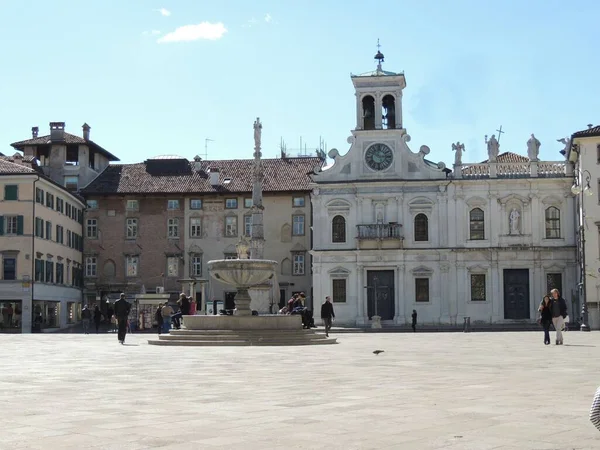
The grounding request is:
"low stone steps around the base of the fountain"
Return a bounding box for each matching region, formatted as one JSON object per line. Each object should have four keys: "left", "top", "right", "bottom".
{"left": 148, "top": 330, "right": 337, "bottom": 347}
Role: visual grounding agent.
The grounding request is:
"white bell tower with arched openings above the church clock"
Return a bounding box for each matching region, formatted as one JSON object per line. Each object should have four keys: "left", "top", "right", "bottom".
{"left": 351, "top": 40, "right": 406, "bottom": 134}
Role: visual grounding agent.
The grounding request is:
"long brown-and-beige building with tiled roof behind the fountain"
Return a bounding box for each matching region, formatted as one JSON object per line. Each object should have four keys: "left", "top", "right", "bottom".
{"left": 81, "top": 156, "right": 322, "bottom": 320}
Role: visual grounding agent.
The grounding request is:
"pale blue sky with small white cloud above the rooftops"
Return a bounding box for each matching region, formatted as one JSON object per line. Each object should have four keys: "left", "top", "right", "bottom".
{"left": 0, "top": 0, "right": 600, "bottom": 166}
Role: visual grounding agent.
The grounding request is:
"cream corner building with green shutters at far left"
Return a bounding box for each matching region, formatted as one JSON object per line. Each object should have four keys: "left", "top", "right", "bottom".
{"left": 0, "top": 154, "right": 84, "bottom": 333}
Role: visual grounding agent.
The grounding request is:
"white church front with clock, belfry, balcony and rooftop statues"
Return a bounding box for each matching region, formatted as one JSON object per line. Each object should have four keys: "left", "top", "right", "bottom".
{"left": 311, "top": 53, "right": 577, "bottom": 325}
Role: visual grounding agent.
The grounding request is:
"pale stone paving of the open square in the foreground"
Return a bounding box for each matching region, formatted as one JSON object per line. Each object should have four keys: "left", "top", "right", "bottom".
{"left": 0, "top": 332, "right": 600, "bottom": 450}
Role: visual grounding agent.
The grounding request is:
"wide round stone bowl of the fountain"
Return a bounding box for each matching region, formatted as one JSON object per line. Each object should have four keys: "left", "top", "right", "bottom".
{"left": 208, "top": 259, "right": 277, "bottom": 289}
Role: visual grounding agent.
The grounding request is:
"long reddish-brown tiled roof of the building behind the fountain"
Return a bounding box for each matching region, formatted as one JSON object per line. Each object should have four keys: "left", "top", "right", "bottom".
{"left": 81, "top": 157, "right": 322, "bottom": 195}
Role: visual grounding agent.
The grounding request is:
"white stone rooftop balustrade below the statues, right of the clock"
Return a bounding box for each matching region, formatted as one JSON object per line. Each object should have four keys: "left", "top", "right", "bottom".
{"left": 453, "top": 161, "right": 573, "bottom": 179}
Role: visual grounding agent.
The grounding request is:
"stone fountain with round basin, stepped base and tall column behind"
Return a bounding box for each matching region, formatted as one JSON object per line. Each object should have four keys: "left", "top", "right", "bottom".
{"left": 148, "top": 118, "right": 336, "bottom": 346}
